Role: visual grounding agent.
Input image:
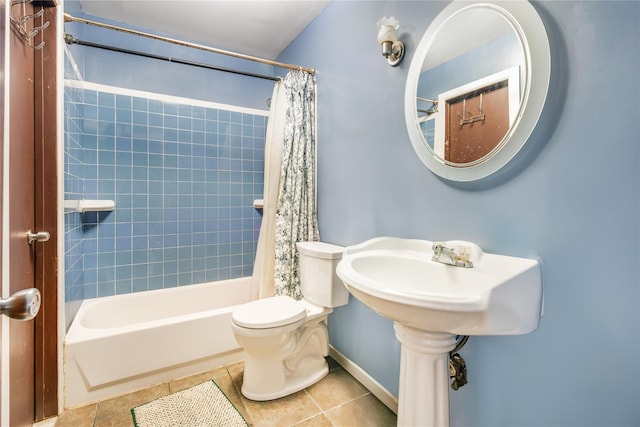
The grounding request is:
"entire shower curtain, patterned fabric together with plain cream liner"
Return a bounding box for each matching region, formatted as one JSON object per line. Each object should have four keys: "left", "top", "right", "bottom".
{"left": 253, "top": 71, "right": 319, "bottom": 300}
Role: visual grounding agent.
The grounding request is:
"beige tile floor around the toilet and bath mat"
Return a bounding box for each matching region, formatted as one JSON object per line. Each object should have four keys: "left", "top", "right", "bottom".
{"left": 55, "top": 358, "right": 396, "bottom": 427}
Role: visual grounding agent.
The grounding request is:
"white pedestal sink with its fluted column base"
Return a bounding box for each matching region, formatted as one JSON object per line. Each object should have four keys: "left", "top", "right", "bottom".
{"left": 336, "top": 237, "right": 542, "bottom": 427}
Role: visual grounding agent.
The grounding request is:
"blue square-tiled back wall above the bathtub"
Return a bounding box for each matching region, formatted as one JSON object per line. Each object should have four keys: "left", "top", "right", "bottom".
{"left": 65, "top": 81, "right": 267, "bottom": 300}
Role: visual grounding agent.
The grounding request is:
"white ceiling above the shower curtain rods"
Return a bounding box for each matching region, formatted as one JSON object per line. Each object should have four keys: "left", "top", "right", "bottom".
{"left": 80, "top": 0, "right": 331, "bottom": 59}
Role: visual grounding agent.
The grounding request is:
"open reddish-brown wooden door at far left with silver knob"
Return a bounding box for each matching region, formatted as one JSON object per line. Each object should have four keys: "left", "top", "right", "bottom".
{"left": 5, "top": 3, "right": 35, "bottom": 427}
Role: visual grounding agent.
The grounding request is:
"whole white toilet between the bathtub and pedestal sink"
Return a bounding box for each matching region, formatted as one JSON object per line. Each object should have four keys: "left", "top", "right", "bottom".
{"left": 231, "top": 242, "right": 349, "bottom": 400}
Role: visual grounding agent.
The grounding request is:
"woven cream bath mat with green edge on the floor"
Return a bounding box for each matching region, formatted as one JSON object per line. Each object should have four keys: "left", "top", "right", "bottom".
{"left": 131, "top": 381, "right": 248, "bottom": 427}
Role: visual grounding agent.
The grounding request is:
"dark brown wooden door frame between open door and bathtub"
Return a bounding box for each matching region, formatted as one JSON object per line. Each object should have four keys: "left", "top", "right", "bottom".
{"left": 34, "top": 1, "right": 61, "bottom": 421}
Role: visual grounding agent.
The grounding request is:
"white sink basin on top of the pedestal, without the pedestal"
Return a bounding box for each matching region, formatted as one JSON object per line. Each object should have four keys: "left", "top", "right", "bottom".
{"left": 336, "top": 237, "right": 542, "bottom": 335}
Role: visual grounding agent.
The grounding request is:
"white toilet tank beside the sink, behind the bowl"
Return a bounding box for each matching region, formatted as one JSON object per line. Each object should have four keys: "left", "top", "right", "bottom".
{"left": 296, "top": 242, "right": 349, "bottom": 307}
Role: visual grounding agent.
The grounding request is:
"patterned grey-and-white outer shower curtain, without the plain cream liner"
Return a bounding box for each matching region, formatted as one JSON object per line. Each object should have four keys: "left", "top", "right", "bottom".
{"left": 274, "top": 71, "right": 320, "bottom": 300}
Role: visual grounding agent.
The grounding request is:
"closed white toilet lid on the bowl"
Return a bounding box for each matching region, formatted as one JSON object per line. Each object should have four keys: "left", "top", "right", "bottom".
{"left": 231, "top": 296, "right": 306, "bottom": 329}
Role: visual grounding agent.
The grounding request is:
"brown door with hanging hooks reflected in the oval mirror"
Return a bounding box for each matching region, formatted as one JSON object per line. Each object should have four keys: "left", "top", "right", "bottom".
{"left": 444, "top": 80, "right": 509, "bottom": 163}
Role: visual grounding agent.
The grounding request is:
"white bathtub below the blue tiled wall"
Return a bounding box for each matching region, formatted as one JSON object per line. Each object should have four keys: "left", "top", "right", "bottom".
{"left": 64, "top": 277, "right": 251, "bottom": 407}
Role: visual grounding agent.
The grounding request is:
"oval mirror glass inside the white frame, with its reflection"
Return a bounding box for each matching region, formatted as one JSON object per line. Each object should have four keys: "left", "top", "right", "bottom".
{"left": 415, "top": 7, "right": 527, "bottom": 167}
